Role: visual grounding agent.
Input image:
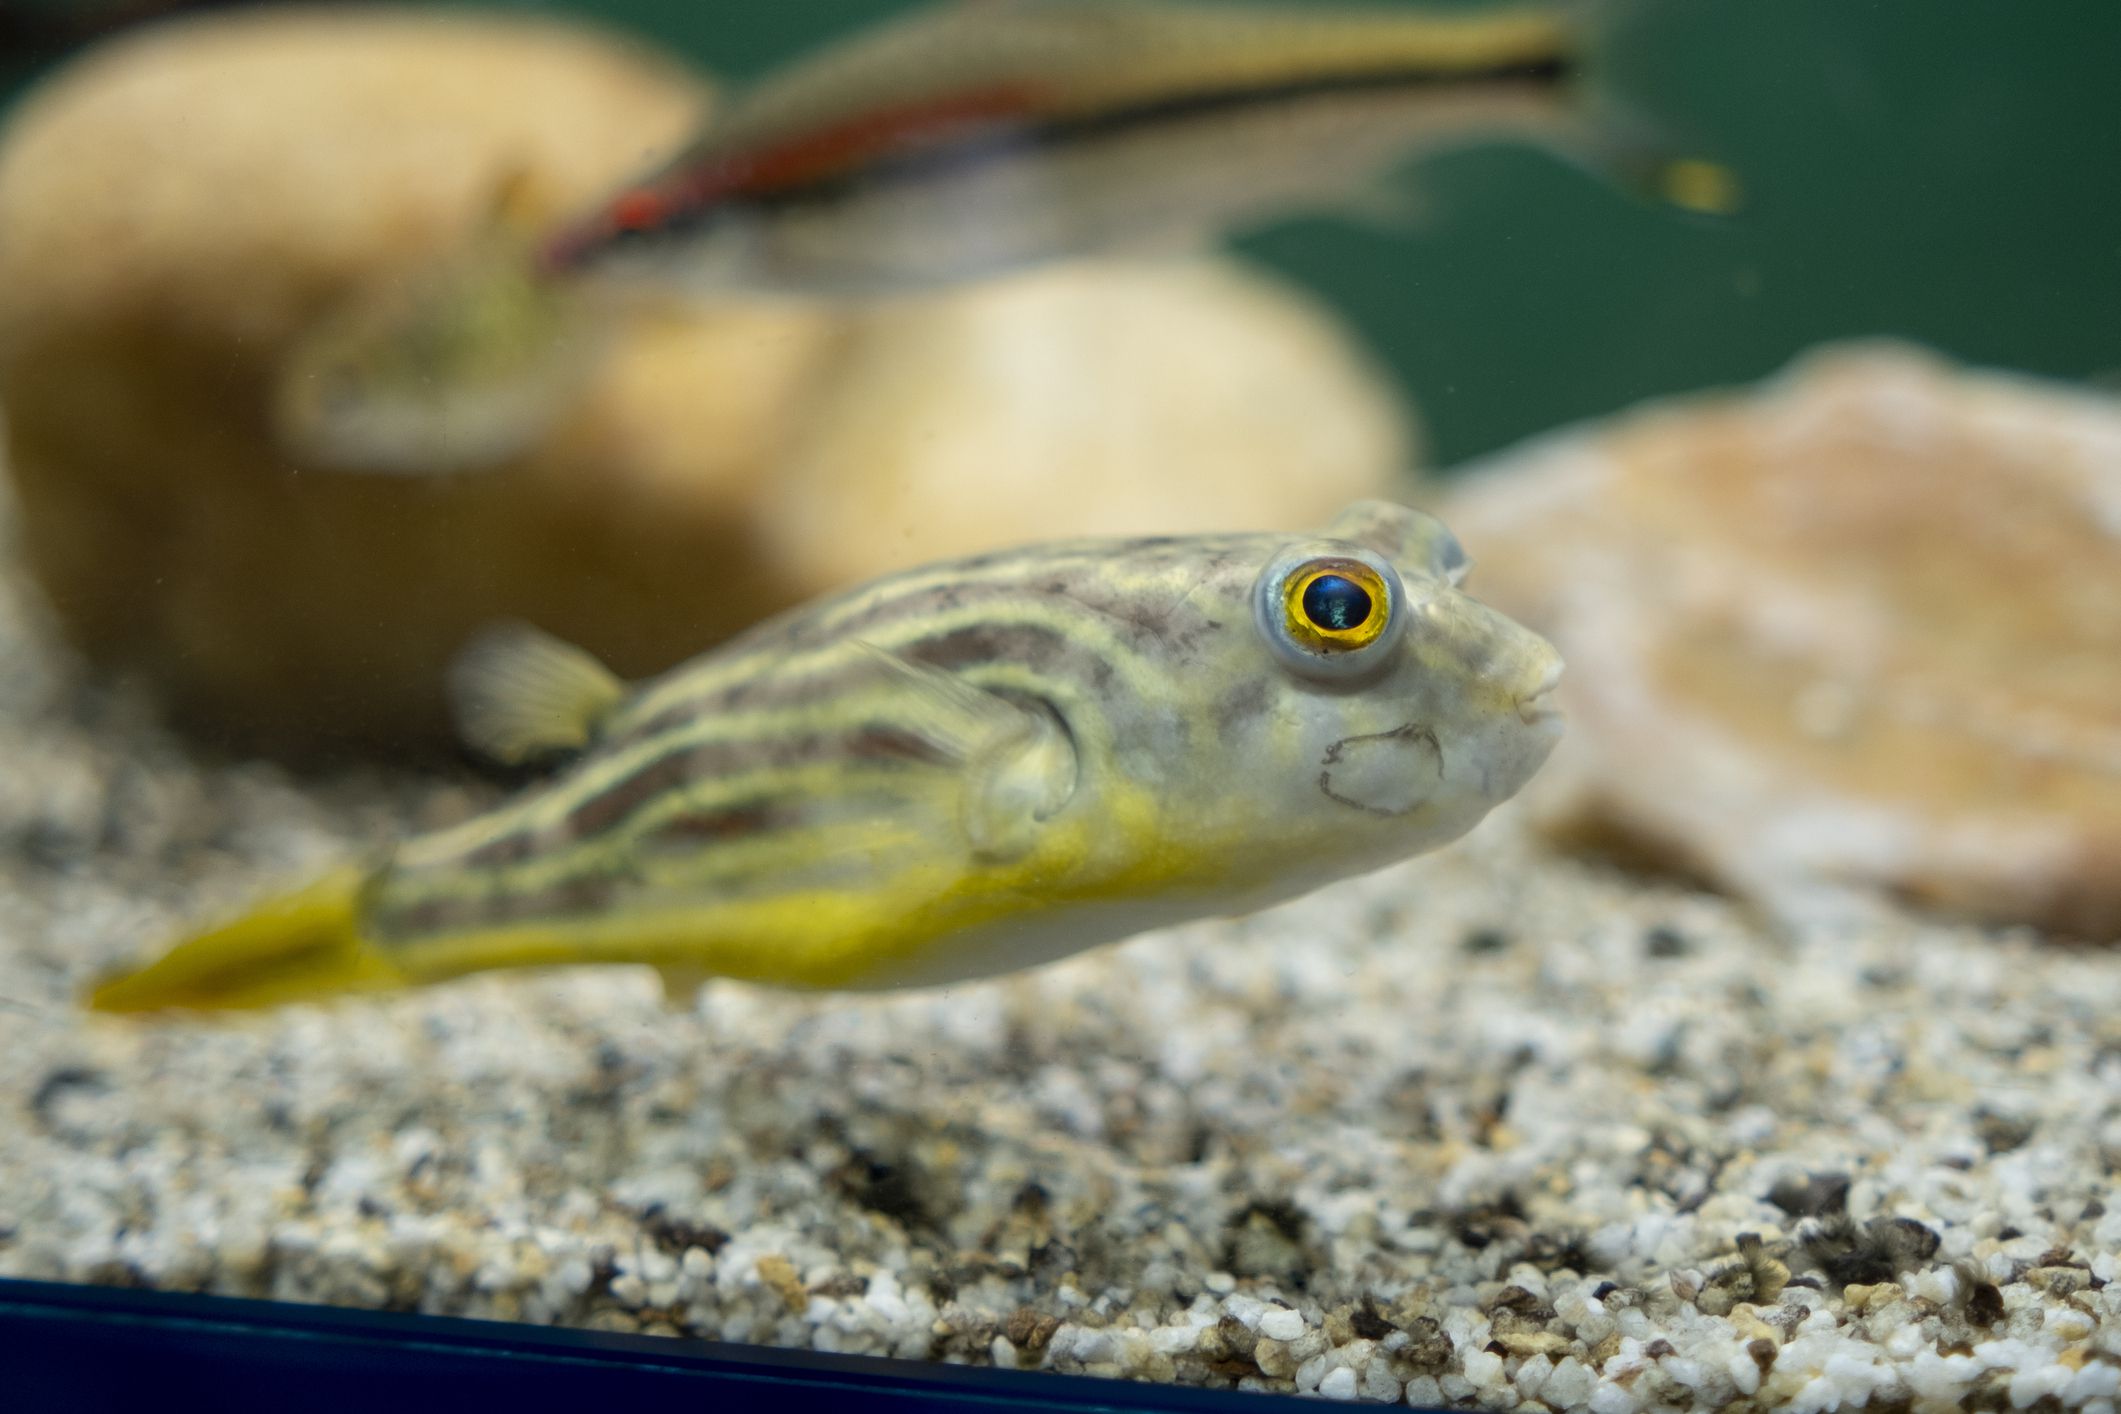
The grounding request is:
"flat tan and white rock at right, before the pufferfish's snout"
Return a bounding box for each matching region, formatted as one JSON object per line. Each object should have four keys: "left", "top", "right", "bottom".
{"left": 1444, "top": 346, "right": 2121, "bottom": 939}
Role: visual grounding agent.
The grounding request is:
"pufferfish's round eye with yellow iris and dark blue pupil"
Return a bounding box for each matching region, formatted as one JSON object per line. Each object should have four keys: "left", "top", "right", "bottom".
{"left": 1251, "top": 545, "right": 1406, "bottom": 681}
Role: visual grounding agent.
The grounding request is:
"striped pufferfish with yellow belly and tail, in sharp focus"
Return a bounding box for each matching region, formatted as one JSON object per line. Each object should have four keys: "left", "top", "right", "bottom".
{"left": 89, "top": 502, "right": 1561, "bottom": 1011}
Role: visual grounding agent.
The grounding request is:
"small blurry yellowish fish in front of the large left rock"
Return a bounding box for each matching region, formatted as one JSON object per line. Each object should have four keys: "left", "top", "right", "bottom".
{"left": 271, "top": 174, "right": 607, "bottom": 475}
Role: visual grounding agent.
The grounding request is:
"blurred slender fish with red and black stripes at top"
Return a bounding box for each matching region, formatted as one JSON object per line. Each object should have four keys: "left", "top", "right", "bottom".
{"left": 547, "top": 0, "right": 1705, "bottom": 295}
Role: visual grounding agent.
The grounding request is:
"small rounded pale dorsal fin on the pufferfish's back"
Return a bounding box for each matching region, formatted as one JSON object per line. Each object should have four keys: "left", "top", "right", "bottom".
{"left": 450, "top": 623, "right": 626, "bottom": 765}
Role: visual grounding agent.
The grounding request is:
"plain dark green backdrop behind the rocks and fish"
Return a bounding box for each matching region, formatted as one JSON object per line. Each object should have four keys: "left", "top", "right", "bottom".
{"left": 0, "top": 0, "right": 2121, "bottom": 462}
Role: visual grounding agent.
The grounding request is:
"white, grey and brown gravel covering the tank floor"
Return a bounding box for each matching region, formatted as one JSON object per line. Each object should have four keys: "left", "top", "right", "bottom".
{"left": 0, "top": 506, "right": 2121, "bottom": 1414}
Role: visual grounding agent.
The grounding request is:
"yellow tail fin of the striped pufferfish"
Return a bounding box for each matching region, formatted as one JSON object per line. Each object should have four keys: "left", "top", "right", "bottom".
{"left": 87, "top": 869, "right": 405, "bottom": 1011}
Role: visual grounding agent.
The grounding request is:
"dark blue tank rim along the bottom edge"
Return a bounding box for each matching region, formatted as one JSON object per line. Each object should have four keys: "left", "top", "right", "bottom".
{"left": 0, "top": 1278, "right": 1450, "bottom": 1414}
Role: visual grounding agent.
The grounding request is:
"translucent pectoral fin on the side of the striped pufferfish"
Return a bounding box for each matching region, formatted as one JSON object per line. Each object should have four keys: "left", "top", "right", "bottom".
{"left": 863, "top": 644, "right": 1080, "bottom": 863}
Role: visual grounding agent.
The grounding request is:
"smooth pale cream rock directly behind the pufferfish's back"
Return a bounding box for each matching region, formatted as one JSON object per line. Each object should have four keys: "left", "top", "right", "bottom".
{"left": 761, "top": 261, "right": 1415, "bottom": 583}
